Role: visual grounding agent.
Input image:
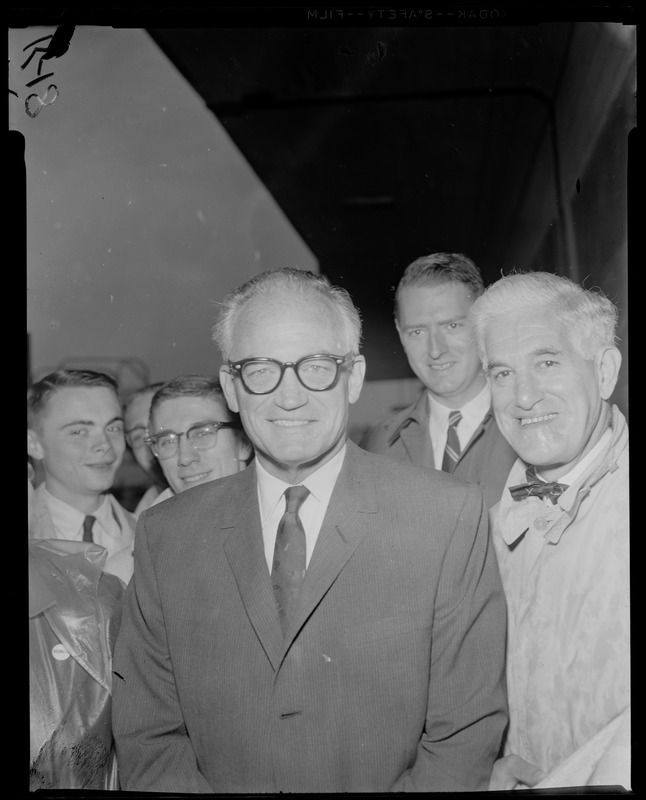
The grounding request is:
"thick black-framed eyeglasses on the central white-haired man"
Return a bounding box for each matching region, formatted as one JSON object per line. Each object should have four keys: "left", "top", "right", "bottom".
{"left": 229, "top": 353, "right": 355, "bottom": 394}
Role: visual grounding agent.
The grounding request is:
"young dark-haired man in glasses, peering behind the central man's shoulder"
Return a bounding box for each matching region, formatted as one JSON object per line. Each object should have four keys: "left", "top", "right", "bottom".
{"left": 145, "top": 374, "right": 252, "bottom": 505}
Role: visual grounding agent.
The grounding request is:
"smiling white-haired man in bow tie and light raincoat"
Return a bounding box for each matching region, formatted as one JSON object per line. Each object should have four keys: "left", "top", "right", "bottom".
{"left": 469, "top": 272, "right": 630, "bottom": 790}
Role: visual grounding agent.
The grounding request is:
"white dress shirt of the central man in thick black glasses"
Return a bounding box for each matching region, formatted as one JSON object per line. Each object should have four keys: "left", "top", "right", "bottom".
{"left": 256, "top": 445, "right": 346, "bottom": 573}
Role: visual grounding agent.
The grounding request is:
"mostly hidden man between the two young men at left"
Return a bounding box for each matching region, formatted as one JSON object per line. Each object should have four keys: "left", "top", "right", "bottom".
{"left": 123, "top": 381, "right": 168, "bottom": 517}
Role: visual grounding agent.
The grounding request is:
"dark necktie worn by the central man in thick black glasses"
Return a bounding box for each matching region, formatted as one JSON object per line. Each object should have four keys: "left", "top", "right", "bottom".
{"left": 271, "top": 486, "right": 310, "bottom": 631}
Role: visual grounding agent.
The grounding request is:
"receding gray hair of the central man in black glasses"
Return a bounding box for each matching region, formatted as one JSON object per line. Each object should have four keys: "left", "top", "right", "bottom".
{"left": 213, "top": 267, "right": 361, "bottom": 361}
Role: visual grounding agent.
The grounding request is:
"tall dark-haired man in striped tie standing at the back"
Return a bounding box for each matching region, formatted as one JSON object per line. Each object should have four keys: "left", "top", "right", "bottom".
{"left": 361, "top": 253, "right": 516, "bottom": 508}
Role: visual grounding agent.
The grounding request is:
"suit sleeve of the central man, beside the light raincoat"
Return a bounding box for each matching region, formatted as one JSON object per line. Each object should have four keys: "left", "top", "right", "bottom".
{"left": 392, "top": 487, "right": 508, "bottom": 792}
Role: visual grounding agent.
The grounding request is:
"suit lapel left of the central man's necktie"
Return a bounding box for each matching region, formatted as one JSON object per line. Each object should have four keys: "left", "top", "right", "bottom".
{"left": 220, "top": 464, "right": 283, "bottom": 670}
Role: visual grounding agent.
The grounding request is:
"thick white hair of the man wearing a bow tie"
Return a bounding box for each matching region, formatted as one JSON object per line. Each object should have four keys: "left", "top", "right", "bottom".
{"left": 469, "top": 272, "right": 619, "bottom": 368}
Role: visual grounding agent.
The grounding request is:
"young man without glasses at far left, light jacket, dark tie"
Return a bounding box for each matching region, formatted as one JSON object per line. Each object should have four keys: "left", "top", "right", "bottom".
{"left": 27, "top": 370, "right": 135, "bottom": 583}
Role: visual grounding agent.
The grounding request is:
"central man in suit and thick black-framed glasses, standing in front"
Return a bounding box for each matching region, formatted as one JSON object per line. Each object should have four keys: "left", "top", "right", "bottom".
{"left": 114, "top": 269, "right": 507, "bottom": 793}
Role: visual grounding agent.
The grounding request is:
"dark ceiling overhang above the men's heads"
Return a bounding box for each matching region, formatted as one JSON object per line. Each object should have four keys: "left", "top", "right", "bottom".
{"left": 147, "top": 23, "right": 574, "bottom": 379}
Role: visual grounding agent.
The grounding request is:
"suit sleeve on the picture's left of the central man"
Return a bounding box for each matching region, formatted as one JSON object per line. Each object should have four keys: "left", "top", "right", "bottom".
{"left": 112, "top": 514, "right": 213, "bottom": 793}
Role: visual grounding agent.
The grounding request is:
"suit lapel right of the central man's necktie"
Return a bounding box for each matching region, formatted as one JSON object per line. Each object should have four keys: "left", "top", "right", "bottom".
{"left": 284, "top": 441, "right": 378, "bottom": 653}
